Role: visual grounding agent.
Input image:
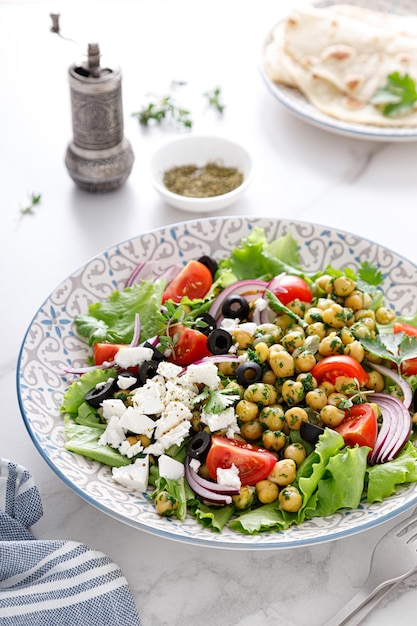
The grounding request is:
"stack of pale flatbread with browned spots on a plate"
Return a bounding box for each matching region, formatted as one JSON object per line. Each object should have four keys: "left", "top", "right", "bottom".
{"left": 263, "top": 4, "right": 417, "bottom": 127}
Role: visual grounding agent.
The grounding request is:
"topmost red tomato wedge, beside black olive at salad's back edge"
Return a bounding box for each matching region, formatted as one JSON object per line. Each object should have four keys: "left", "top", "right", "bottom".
{"left": 162, "top": 261, "right": 213, "bottom": 303}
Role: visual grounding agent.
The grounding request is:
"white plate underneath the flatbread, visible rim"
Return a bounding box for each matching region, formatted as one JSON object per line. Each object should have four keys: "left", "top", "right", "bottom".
{"left": 260, "top": 0, "right": 417, "bottom": 142}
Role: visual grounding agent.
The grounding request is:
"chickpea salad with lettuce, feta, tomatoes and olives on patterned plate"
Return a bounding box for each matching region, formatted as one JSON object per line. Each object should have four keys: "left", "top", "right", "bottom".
{"left": 61, "top": 227, "right": 417, "bottom": 534}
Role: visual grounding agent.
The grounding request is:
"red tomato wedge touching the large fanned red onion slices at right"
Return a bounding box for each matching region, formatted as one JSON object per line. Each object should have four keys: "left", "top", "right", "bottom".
{"left": 334, "top": 402, "right": 378, "bottom": 450}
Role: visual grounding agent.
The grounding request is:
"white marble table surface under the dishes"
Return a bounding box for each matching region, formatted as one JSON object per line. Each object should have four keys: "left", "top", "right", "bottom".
{"left": 0, "top": 0, "right": 417, "bottom": 626}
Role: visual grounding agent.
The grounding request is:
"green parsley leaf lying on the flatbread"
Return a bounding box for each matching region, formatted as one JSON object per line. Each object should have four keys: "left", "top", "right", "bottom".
{"left": 371, "top": 72, "right": 417, "bottom": 117}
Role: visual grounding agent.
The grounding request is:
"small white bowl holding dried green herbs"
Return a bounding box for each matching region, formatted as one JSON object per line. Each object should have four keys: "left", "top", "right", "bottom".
{"left": 150, "top": 135, "right": 253, "bottom": 213}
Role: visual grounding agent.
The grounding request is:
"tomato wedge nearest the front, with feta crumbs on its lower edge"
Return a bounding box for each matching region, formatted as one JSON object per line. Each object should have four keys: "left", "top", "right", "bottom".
{"left": 206, "top": 435, "right": 277, "bottom": 485}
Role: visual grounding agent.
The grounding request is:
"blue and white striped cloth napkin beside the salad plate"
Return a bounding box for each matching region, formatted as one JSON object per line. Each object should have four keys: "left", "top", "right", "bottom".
{"left": 0, "top": 459, "right": 140, "bottom": 626}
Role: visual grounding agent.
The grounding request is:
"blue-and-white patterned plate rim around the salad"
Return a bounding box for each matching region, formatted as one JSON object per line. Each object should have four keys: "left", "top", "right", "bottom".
{"left": 17, "top": 217, "right": 417, "bottom": 549}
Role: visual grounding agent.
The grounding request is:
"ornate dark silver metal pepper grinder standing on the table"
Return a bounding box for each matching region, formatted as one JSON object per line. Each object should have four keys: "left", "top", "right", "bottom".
{"left": 65, "top": 43, "right": 134, "bottom": 192}
